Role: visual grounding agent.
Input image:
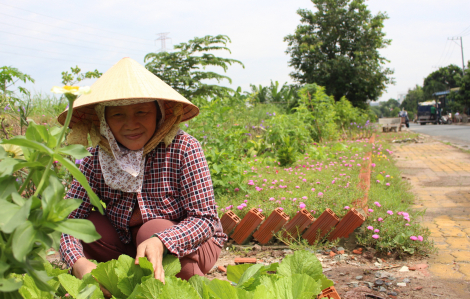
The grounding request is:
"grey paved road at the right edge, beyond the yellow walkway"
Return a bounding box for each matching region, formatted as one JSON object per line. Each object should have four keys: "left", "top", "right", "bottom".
{"left": 410, "top": 123, "right": 470, "bottom": 148}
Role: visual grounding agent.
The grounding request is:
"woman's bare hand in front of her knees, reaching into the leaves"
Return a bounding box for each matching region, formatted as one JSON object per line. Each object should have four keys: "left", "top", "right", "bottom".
{"left": 135, "top": 237, "right": 165, "bottom": 283}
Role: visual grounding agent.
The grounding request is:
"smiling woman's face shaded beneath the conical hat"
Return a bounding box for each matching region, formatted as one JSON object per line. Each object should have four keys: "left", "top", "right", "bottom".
{"left": 105, "top": 102, "right": 158, "bottom": 150}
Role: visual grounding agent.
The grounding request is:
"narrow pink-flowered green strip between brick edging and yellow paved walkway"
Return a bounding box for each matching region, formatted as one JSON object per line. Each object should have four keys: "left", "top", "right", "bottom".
{"left": 357, "top": 133, "right": 435, "bottom": 255}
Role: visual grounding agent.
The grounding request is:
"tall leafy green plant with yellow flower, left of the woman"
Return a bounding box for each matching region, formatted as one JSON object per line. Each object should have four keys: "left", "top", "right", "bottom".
{"left": 0, "top": 88, "right": 103, "bottom": 298}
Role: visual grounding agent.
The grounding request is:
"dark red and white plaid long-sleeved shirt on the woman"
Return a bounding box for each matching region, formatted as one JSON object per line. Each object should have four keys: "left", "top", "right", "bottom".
{"left": 60, "top": 131, "right": 227, "bottom": 267}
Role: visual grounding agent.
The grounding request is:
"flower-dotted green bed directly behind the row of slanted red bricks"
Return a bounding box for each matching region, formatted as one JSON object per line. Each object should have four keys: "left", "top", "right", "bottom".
{"left": 217, "top": 140, "right": 370, "bottom": 217}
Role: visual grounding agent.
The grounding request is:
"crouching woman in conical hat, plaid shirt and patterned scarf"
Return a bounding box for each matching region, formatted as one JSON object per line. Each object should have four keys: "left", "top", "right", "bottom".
{"left": 58, "top": 58, "right": 227, "bottom": 288}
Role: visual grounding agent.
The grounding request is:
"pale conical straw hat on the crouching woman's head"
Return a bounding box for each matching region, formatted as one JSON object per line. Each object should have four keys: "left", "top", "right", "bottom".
{"left": 57, "top": 57, "right": 199, "bottom": 128}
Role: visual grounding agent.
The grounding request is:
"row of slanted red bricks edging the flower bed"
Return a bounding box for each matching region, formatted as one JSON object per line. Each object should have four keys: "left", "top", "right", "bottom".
{"left": 220, "top": 208, "right": 365, "bottom": 245}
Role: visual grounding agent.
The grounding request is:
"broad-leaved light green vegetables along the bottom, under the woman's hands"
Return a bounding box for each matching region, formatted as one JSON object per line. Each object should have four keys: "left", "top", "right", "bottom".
{"left": 13, "top": 251, "right": 333, "bottom": 299}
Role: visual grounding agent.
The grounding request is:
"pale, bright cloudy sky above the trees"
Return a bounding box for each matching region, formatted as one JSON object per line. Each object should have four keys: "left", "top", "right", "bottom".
{"left": 0, "top": 0, "right": 470, "bottom": 101}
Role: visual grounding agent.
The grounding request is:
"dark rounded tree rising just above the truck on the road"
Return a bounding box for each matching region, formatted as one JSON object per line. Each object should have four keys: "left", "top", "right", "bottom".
{"left": 423, "top": 64, "right": 462, "bottom": 100}
